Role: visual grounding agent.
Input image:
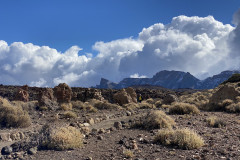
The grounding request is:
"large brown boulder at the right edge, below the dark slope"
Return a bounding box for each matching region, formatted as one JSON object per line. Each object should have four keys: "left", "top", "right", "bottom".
{"left": 209, "top": 83, "right": 240, "bottom": 105}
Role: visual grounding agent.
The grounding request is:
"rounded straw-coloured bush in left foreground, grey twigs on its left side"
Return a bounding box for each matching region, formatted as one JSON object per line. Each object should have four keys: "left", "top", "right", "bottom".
{"left": 40, "top": 126, "right": 83, "bottom": 151}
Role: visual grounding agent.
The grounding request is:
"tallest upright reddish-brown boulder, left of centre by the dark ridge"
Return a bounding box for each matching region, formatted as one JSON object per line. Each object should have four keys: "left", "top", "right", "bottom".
{"left": 53, "top": 83, "right": 72, "bottom": 103}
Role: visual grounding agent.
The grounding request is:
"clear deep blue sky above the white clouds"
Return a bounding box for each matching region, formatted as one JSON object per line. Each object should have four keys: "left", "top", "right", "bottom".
{"left": 0, "top": 0, "right": 240, "bottom": 53}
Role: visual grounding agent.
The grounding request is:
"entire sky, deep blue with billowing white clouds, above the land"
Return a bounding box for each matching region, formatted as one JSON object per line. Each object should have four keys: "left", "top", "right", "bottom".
{"left": 0, "top": 0, "right": 240, "bottom": 87}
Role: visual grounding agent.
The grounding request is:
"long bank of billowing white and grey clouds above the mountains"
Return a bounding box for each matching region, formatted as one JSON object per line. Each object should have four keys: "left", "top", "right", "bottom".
{"left": 0, "top": 10, "right": 240, "bottom": 87}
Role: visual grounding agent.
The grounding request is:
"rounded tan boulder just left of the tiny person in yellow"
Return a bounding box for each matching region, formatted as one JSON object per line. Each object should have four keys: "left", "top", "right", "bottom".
{"left": 113, "top": 88, "right": 137, "bottom": 105}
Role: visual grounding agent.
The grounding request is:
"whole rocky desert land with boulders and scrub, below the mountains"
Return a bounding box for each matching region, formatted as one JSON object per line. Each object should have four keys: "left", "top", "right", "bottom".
{"left": 0, "top": 77, "right": 240, "bottom": 160}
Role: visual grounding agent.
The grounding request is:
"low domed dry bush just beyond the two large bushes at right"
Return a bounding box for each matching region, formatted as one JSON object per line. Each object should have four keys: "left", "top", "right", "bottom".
{"left": 169, "top": 102, "right": 200, "bottom": 115}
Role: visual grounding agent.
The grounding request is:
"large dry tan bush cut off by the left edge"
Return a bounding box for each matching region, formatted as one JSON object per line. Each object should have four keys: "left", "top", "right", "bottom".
{"left": 0, "top": 97, "right": 31, "bottom": 128}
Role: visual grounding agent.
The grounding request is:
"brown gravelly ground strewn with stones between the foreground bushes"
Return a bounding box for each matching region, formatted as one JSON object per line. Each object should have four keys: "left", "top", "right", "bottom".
{"left": 0, "top": 81, "right": 240, "bottom": 160}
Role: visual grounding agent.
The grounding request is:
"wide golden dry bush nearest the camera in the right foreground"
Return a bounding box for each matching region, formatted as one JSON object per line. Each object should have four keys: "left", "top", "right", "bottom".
{"left": 154, "top": 128, "right": 204, "bottom": 150}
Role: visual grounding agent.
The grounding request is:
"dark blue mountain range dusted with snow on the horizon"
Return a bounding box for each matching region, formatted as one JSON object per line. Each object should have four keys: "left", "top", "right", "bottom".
{"left": 95, "top": 70, "right": 240, "bottom": 89}
